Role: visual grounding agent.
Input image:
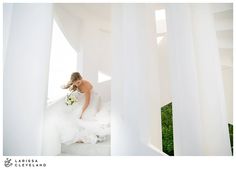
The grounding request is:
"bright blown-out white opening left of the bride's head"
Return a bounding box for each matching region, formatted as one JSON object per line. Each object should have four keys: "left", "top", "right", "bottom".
{"left": 48, "top": 20, "right": 77, "bottom": 102}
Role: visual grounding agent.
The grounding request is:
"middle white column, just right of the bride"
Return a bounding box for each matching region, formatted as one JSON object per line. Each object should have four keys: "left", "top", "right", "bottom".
{"left": 111, "top": 4, "right": 162, "bottom": 155}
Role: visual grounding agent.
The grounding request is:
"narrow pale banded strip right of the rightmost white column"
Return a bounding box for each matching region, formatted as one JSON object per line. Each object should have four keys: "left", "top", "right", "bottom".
{"left": 211, "top": 3, "right": 233, "bottom": 123}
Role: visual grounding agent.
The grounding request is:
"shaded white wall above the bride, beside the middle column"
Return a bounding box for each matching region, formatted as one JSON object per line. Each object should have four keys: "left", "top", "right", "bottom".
{"left": 81, "top": 20, "right": 112, "bottom": 101}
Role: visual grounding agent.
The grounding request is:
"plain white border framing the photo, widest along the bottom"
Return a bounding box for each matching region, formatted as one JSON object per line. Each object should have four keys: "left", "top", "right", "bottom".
{"left": 0, "top": 0, "right": 236, "bottom": 169}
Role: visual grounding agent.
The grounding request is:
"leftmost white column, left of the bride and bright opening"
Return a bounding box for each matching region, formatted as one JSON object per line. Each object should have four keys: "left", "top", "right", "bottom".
{"left": 3, "top": 4, "right": 52, "bottom": 156}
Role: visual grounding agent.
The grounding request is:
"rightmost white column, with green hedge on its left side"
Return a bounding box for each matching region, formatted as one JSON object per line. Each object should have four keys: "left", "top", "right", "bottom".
{"left": 167, "top": 4, "right": 231, "bottom": 155}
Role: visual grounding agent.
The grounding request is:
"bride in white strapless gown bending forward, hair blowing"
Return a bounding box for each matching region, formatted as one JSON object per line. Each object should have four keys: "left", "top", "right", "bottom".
{"left": 61, "top": 72, "right": 110, "bottom": 144}
